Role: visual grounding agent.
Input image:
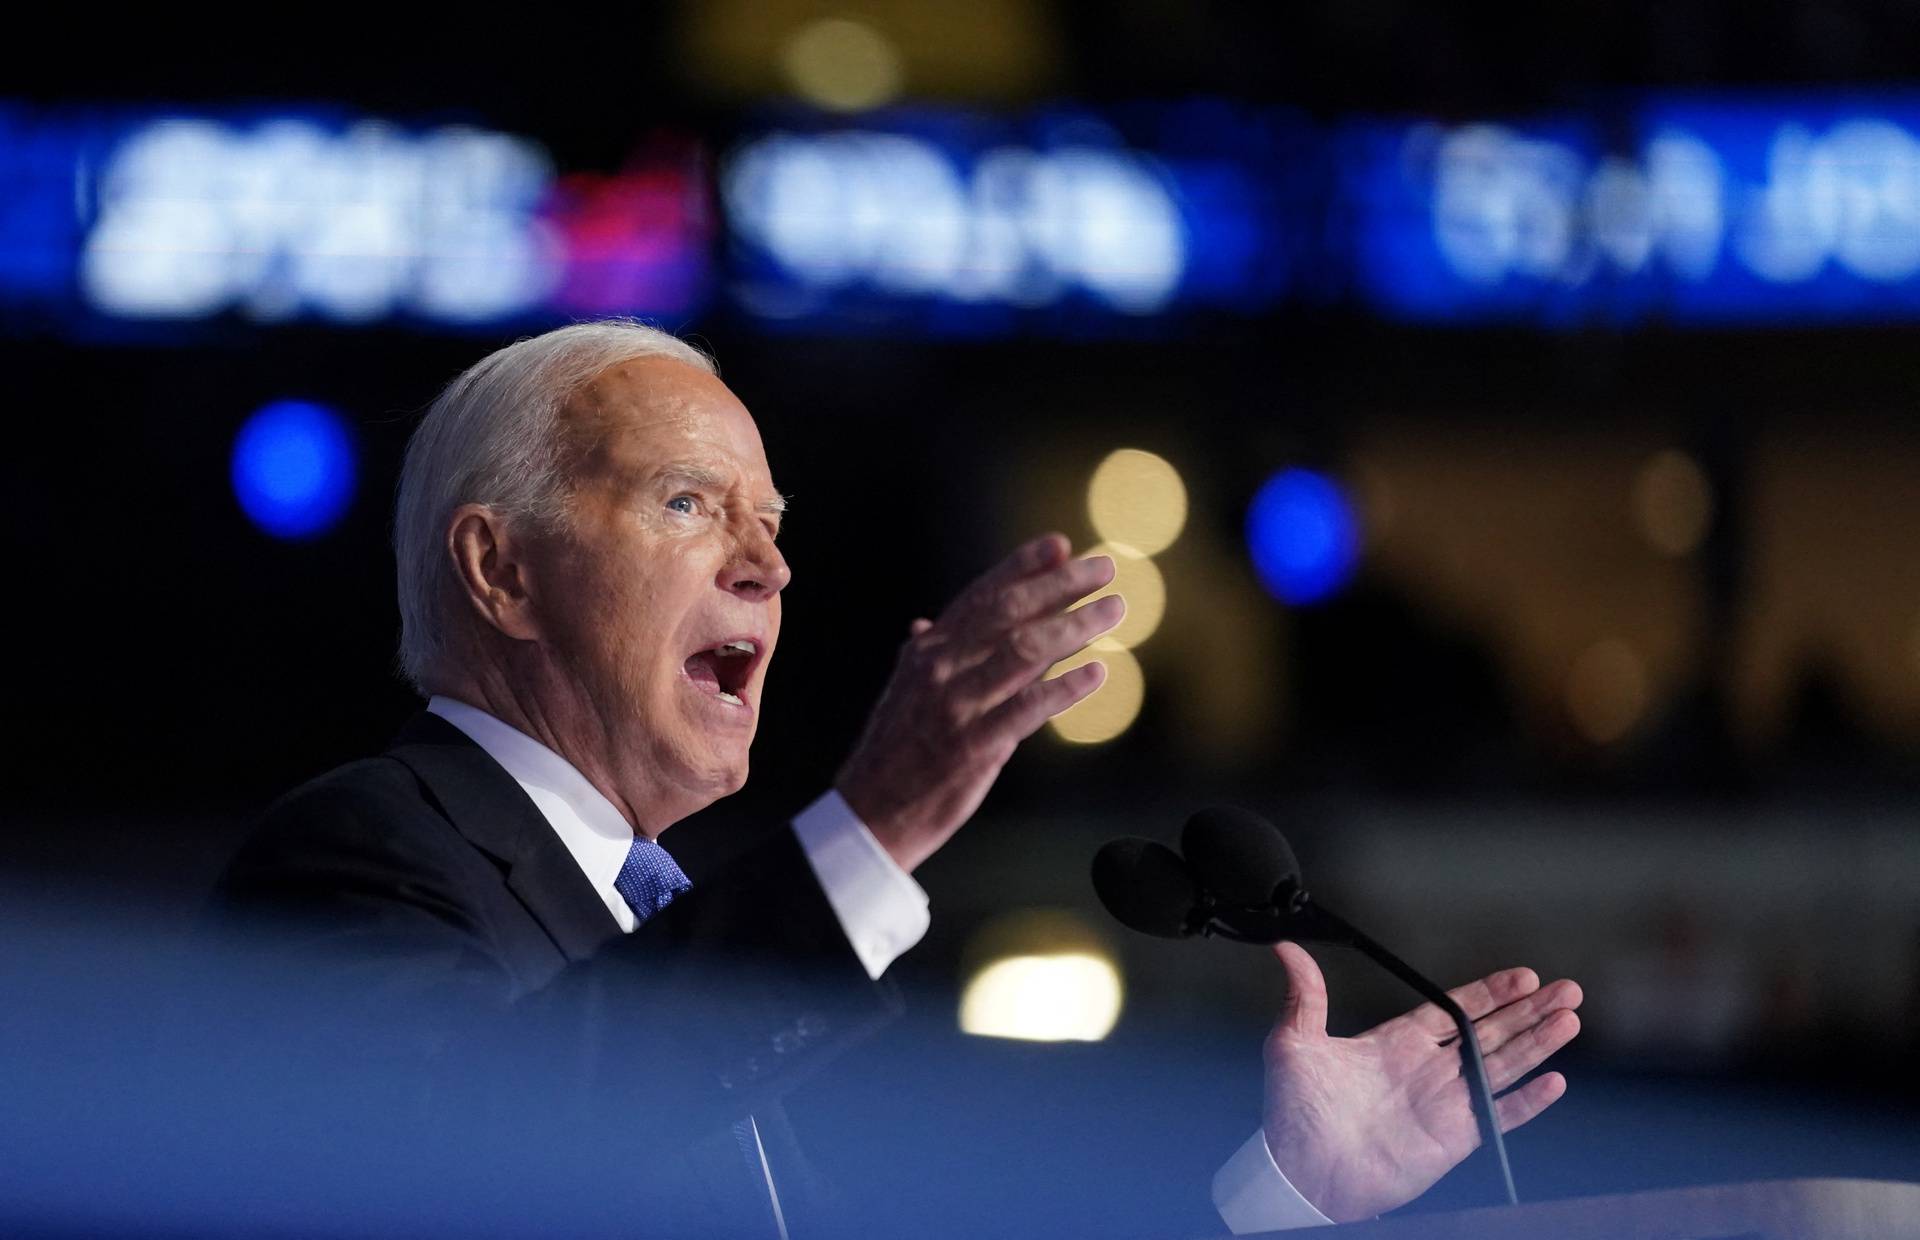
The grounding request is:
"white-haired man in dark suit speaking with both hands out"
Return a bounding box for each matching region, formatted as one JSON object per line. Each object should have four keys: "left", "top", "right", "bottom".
{"left": 223, "top": 322, "right": 1580, "bottom": 1234}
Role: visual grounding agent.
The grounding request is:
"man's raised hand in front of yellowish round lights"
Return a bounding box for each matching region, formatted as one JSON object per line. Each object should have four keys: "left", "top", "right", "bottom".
{"left": 833, "top": 534, "right": 1127, "bottom": 870}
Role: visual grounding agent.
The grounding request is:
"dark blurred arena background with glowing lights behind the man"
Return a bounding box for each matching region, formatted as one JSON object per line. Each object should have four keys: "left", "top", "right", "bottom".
{"left": 0, "top": 0, "right": 1920, "bottom": 1219}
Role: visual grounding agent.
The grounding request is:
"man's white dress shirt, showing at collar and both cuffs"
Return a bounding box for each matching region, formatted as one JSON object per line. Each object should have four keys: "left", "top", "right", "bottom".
{"left": 426, "top": 697, "right": 1331, "bottom": 1234}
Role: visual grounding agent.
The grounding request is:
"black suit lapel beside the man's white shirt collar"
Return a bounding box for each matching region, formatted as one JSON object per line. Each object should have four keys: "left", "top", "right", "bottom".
{"left": 388, "top": 710, "right": 620, "bottom": 960}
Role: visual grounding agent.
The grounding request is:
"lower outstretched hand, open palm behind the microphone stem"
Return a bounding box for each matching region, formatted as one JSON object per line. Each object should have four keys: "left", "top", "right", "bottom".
{"left": 1261, "top": 942, "right": 1580, "bottom": 1223}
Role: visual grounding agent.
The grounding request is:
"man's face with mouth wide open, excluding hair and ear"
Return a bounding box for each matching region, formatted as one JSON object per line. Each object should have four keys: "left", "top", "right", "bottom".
{"left": 530, "top": 357, "right": 789, "bottom": 825}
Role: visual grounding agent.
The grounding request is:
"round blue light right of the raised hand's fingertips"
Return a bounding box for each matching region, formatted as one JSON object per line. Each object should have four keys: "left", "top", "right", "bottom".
{"left": 1246, "top": 468, "right": 1359, "bottom": 607}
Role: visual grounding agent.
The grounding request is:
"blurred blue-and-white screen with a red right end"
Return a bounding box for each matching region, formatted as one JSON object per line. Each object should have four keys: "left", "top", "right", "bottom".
{"left": 0, "top": 109, "right": 710, "bottom": 328}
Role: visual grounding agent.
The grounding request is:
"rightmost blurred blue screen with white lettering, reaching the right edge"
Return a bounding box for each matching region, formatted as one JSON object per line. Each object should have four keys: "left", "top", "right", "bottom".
{"left": 1334, "top": 94, "right": 1920, "bottom": 324}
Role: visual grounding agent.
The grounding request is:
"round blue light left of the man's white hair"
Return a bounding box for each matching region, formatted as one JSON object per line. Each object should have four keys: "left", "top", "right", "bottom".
{"left": 232, "top": 401, "right": 355, "bottom": 539}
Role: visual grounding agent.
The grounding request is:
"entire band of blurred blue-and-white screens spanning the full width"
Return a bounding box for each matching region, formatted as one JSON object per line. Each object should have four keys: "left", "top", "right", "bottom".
{"left": 11, "top": 92, "right": 1920, "bottom": 338}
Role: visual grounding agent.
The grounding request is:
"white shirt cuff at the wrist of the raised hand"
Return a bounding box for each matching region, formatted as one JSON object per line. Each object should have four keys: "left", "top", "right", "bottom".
{"left": 793, "top": 789, "right": 933, "bottom": 981}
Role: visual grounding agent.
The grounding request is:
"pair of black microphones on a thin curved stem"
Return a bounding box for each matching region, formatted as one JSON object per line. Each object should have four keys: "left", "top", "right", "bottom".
{"left": 1092, "top": 806, "right": 1521, "bottom": 1205}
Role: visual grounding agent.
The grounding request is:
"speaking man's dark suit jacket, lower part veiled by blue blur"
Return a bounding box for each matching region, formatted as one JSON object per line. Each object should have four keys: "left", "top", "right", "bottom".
{"left": 215, "top": 714, "right": 897, "bottom": 1234}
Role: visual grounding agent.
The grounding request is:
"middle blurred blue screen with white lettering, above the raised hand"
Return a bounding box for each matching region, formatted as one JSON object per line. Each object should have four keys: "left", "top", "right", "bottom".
{"left": 720, "top": 104, "right": 1306, "bottom": 332}
